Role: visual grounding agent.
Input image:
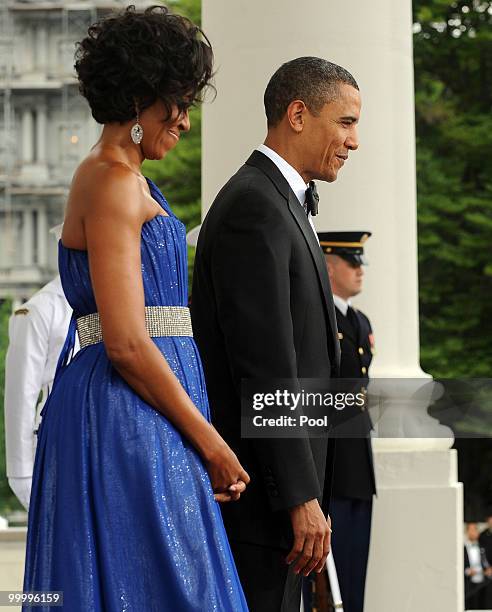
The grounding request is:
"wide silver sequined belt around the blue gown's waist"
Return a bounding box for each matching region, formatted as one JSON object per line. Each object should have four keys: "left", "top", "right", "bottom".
{"left": 77, "top": 306, "right": 193, "bottom": 349}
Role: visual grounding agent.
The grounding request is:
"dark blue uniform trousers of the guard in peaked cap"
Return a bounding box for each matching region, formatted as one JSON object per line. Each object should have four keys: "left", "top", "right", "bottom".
{"left": 330, "top": 497, "right": 372, "bottom": 612}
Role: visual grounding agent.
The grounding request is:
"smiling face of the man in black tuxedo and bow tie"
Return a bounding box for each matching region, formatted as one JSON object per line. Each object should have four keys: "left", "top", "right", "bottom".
{"left": 302, "top": 83, "right": 361, "bottom": 183}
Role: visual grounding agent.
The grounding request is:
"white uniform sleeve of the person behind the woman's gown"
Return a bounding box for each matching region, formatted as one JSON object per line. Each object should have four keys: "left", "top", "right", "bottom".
{"left": 5, "top": 307, "right": 52, "bottom": 478}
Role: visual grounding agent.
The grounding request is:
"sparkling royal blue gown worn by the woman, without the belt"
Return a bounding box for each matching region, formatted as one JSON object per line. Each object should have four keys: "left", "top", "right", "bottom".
{"left": 24, "top": 179, "right": 247, "bottom": 612}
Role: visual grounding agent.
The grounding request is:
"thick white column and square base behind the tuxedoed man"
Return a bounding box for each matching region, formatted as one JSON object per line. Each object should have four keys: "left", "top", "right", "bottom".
{"left": 202, "top": 0, "right": 463, "bottom": 612}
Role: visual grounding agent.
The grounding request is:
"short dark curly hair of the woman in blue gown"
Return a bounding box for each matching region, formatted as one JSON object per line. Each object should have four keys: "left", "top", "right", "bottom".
{"left": 75, "top": 4, "right": 213, "bottom": 123}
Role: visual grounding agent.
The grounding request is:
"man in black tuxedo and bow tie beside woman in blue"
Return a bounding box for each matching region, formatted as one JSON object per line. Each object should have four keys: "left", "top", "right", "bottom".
{"left": 192, "top": 57, "right": 360, "bottom": 612}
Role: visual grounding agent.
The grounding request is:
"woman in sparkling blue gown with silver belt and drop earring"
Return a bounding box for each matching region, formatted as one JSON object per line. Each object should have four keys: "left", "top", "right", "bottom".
{"left": 24, "top": 6, "right": 249, "bottom": 612}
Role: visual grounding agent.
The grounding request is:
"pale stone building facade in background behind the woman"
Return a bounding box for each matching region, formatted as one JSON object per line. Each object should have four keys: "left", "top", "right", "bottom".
{"left": 0, "top": 0, "right": 149, "bottom": 304}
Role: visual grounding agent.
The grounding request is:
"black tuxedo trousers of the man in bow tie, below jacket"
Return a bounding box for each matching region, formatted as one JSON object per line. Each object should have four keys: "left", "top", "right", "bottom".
{"left": 230, "top": 541, "right": 302, "bottom": 612}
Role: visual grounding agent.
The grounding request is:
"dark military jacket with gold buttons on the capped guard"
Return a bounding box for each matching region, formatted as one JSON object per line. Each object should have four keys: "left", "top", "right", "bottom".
{"left": 333, "top": 307, "right": 376, "bottom": 499}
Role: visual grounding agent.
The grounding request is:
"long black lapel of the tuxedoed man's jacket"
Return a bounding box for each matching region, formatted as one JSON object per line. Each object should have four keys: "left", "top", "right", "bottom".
{"left": 246, "top": 151, "right": 340, "bottom": 370}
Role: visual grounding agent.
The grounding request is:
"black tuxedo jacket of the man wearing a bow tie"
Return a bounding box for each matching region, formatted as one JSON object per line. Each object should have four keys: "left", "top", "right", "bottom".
{"left": 191, "top": 151, "right": 340, "bottom": 549}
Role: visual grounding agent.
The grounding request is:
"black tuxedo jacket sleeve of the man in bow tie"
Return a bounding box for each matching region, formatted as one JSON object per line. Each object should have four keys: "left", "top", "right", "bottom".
{"left": 211, "top": 190, "right": 321, "bottom": 511}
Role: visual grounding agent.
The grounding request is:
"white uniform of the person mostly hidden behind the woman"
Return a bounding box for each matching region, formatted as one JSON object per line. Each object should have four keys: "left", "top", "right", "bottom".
{"left": 5, "top": 276, "right": 72, "bottom": 509}
